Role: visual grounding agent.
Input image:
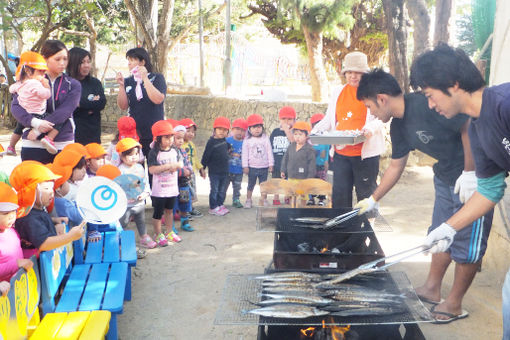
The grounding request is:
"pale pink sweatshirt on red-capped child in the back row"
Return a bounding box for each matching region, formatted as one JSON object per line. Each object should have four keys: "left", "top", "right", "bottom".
{"left": 241, "top": 134, "right": 274, "bottom": 169}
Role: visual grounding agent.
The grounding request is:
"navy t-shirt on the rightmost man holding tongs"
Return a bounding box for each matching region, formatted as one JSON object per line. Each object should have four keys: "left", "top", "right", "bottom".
{"left": 469, "top": 83, "right": 510, "bottom": 178}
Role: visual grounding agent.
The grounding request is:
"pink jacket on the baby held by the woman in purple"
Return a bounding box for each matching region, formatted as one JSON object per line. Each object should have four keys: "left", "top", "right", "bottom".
{"left": 9, "top": 79, "right": 51, "bottom": 115}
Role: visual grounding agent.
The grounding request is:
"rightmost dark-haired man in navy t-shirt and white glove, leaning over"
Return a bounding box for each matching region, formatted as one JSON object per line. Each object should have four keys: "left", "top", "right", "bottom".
{"left": 411, "top": 45, "right": 510, "bottom": 339}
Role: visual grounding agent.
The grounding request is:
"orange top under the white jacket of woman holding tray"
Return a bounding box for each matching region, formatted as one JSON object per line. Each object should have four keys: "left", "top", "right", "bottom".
{"left": 335, "top": 84, "right": 367, "bottom": 156}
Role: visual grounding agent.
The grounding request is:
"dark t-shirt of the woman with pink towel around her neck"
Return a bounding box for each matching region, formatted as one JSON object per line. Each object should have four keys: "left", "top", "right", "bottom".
{"left": 124, "top": 73, "right": 166, "bottom": 140}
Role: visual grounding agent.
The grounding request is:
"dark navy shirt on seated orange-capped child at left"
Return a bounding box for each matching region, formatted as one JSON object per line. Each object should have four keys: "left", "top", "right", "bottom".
{"left": 15, "top": 208, "right": 57, "bottom": 249}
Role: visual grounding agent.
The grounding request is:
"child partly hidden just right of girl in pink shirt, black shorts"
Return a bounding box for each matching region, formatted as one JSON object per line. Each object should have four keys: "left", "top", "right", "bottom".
{"left": 173, "top": 125, "right": 195, "bottom": 234}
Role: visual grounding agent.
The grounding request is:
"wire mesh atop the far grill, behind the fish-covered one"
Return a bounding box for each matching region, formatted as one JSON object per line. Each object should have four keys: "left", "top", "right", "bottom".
{"left": 256, "top": 207, "right": 393, "bottom": 233}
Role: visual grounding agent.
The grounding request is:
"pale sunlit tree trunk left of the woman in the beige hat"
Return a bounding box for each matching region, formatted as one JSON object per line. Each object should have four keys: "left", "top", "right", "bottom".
{"left": 303, "top": 25, "right": 328, "bottom": 102}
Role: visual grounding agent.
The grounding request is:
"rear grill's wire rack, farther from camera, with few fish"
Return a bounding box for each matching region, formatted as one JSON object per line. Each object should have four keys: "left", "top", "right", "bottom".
{"left": 256, "top": 207, "right": 393, "bottom": 233}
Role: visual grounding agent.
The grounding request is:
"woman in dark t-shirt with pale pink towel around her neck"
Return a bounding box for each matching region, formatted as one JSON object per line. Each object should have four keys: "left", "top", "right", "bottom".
{"left": 116, "top": 47, "right": 166, "bottom": 158}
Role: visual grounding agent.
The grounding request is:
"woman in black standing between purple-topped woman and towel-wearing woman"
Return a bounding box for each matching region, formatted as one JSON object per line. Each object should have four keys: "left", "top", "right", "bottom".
{"left": 67, "top": 47, "right": 106, "bottom": 145}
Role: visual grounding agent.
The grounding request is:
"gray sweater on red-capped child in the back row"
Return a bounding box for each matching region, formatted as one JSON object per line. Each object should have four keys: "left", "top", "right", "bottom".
{"left": 281, "top": 142, "right": 316, "bottom": 179}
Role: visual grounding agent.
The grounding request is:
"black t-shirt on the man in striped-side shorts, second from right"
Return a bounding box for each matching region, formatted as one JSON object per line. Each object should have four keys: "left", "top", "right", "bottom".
{"left": 390, "top": 93, "right": 468, "bottom": 185}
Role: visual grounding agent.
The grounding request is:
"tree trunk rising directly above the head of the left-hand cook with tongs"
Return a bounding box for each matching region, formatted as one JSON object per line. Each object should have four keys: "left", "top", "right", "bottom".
{"left": 383, "top": 0, "right": 409, "bottom": 92}
